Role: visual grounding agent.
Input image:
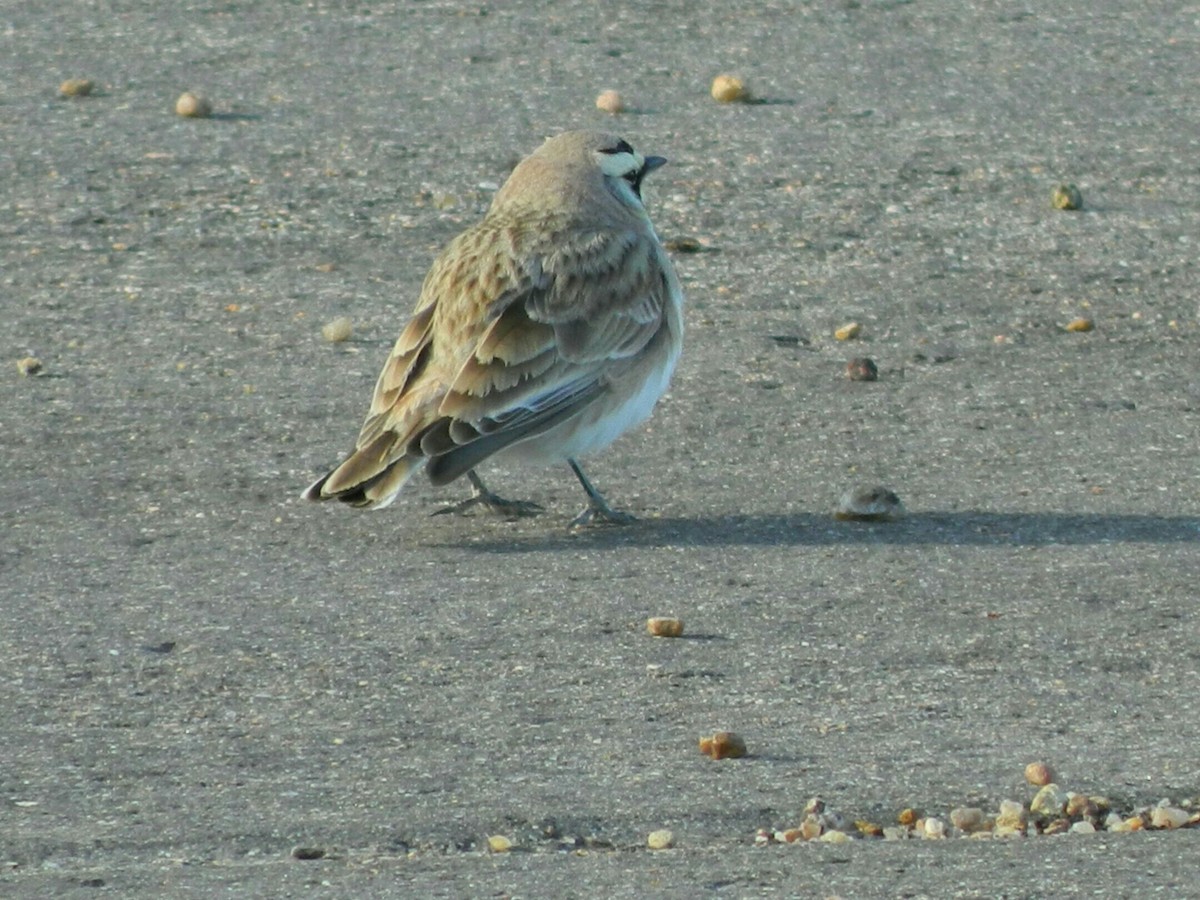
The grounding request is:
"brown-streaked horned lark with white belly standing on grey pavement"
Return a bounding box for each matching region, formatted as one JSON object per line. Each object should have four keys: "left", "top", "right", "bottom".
{"left": 304, "top": 131, "right": 683, "bottom": 524}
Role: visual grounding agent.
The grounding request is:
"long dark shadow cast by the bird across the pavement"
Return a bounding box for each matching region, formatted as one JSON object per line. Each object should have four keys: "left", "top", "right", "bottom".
{"left": 458, "top": 510, "right": 1200, "bottom": 553}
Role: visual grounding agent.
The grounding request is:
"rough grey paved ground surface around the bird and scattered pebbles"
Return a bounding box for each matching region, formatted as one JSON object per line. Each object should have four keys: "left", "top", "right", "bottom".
{"left": 0, "top": 0, "right": 1200, "bottom": 898}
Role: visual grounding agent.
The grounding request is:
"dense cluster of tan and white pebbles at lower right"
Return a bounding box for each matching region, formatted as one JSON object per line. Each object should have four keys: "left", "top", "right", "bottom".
{"left": 754, "top": 781, "right": 1200, "bottom": 846}
